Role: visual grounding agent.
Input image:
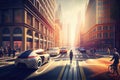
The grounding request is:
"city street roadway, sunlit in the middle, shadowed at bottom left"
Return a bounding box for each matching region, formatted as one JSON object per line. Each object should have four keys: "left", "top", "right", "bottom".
{"left": 0, "top": 51, "right": 118, "bottom": 80}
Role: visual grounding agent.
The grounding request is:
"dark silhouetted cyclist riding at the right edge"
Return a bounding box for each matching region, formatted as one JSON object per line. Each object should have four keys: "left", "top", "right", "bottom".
{"left": 110, "top": 48, "right": 120, "bottom": 75}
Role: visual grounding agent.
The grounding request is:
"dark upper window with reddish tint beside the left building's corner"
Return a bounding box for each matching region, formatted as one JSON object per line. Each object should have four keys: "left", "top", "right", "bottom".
{"left": 14, "top": 9, "right": 23, "bottom": 23}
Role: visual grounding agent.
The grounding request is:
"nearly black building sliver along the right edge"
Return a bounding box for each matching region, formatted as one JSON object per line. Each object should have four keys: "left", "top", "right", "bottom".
{"left": 110, "top": 0, "right": 120, "bottom": 53}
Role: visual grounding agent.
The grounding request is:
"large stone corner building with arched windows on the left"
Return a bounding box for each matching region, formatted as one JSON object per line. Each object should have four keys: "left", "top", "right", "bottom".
{"left": 0, "top": 0, "right": 55, "bottom": 51}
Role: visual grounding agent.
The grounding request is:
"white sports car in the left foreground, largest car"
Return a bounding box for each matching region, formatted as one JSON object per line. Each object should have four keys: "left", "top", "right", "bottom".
{"left": 15, "top": 49, "right": 50, "bottom": 69}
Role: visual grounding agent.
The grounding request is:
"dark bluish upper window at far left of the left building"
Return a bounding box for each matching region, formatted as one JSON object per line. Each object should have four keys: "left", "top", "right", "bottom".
{"left": 2, "top": 10, "right": 12, "bottom": 23}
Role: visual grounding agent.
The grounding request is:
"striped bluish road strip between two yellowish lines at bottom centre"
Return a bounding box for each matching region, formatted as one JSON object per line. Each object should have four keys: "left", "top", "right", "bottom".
{"left": 57, "top": 60, "right": 86, "bottom": 80}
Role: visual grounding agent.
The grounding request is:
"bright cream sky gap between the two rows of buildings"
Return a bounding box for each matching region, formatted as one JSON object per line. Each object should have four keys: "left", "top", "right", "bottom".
{"left": 57, "top": 0, "right": 88, "bottom": 44}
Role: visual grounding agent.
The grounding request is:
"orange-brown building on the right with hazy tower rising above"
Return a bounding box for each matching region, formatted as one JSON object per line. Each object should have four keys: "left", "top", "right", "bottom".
{"left": 82, "top": 0, "right": 115, "bottom": 50}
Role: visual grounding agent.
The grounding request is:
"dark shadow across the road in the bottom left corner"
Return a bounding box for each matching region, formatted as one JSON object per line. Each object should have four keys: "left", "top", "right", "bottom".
{"left": 0, "top": 65, "right": 35, "bottom": 80}
